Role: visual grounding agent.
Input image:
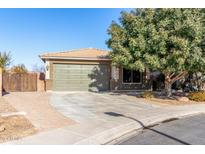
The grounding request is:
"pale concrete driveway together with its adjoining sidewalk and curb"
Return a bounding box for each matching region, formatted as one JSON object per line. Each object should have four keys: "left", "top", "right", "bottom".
{"left": 3, "top": 93, "right": 205, "bottom": 144}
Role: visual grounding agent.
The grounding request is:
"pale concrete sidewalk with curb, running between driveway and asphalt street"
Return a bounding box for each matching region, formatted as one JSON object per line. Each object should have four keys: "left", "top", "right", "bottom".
{"left": 5, "top": 104, "right": 205, "bottom": 145}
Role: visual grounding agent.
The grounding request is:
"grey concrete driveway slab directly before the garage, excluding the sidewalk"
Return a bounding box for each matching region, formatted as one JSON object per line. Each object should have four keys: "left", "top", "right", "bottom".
{"left": 50, "top": 92, "right": 160, "bottom": 123}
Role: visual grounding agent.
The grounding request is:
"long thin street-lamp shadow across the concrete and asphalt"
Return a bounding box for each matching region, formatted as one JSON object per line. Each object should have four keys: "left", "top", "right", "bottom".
{"left": 104, "top": 112, "right": 190, "bottom": 145}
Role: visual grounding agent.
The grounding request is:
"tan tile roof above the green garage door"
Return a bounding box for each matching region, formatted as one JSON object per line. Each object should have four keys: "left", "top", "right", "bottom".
{"left": 40, "top": 48, "right": 109, "bottom": 59}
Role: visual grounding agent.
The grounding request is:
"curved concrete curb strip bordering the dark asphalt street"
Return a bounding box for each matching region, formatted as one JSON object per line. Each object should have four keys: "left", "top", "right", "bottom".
{"left": 74, "top": 111, "right": 205, "bottom": 145}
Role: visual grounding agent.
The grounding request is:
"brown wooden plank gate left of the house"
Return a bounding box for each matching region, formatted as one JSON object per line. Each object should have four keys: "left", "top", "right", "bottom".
{"left": 3, "top": 73, "right": 37, "bottom": 92}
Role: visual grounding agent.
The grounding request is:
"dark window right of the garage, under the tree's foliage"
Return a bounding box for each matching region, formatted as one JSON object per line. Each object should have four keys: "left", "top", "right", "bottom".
{"left": 123, "top": 68, "right": 141, "bottom": 83}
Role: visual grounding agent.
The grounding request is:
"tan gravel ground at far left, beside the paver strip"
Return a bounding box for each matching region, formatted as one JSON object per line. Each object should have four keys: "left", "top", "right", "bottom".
{"left": 0, "top": 98, "right": 37, "bottom": 143}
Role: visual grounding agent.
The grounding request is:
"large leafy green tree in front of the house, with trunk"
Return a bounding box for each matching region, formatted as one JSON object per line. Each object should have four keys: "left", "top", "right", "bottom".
{"left": 107, "top": 9, "right": 205, "bottom": 96}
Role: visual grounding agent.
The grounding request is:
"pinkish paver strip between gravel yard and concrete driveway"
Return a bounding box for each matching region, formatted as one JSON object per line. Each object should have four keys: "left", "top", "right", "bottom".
{"left": 3, "top": 92, "right": 75, "bottom": 132}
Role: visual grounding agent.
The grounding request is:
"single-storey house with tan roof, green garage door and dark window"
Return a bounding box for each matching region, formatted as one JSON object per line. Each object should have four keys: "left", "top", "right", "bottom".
{"left": 40, "top": 48, "right": 150, "bottom": 91}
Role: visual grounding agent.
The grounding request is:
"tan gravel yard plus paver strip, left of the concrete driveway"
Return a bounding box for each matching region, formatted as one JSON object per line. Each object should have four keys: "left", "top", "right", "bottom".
{"left": 0, "top": 92, "right": 75, "bottom": 143}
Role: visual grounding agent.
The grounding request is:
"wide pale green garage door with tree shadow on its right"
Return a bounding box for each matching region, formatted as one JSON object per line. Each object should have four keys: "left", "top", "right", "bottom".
{"left": 53, "top": 64, "right": 109, "bottom": 91}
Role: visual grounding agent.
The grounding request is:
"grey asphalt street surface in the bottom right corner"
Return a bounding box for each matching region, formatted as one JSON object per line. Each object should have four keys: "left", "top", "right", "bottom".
{"left": 119, "top": 114, "right": 205, "bottom": 145}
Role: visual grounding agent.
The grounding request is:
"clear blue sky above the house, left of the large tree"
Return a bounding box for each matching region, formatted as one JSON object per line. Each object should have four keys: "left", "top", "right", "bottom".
{"left": 0, "top": 9, "right": 130, "bottom": 70}
